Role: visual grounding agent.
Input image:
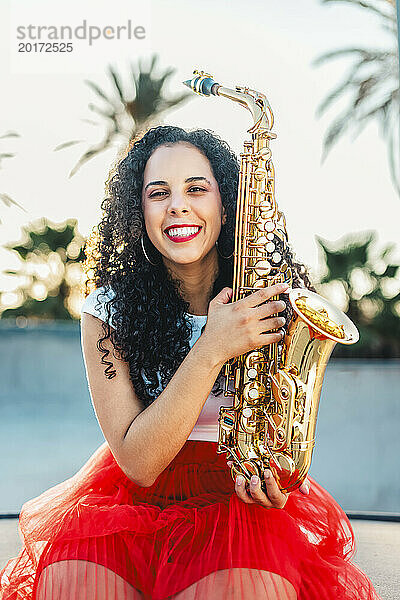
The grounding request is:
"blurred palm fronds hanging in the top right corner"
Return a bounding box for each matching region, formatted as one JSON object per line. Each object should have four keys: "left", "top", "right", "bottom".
{"left": 313, "top": 0, "right": 400, "bottom": 195}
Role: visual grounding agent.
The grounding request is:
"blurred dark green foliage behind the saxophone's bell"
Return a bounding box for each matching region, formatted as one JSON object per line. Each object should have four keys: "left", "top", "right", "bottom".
{"left": 317, "top": 232, "right": 400, "bottom": 358}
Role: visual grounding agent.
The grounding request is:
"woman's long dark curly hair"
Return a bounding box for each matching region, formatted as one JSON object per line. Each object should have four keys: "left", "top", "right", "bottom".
{"left": 85, "top": 126, "right": 314, "bottom": 406}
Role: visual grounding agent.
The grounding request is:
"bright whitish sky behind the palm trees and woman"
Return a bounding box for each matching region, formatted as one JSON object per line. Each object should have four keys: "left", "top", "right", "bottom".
{"left": 0, "top": 0, "right": 400, "bottom": 308}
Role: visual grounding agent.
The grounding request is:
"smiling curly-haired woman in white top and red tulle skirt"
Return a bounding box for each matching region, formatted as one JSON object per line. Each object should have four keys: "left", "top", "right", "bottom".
{"left": 1, "top": 126, "right": 378, "bottom": 600}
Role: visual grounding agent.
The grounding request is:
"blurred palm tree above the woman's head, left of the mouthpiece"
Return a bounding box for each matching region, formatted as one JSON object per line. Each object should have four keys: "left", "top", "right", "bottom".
{"left": 55, "top": 54, "right": 192, "bottom": 177}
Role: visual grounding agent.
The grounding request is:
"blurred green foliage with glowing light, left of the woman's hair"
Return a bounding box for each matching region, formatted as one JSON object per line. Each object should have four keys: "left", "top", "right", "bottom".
{"left": 1, "top": 218, "right": 85, "bottom": 320}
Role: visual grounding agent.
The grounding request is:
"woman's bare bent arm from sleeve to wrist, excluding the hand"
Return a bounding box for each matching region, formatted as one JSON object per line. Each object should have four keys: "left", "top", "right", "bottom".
{"left": 81, "top": 313, "right": 224, "bottom": 487}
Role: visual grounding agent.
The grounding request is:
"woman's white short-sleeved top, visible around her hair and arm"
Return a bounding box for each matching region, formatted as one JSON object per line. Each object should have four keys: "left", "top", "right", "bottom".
{"left": 81, "top": 287, "right": 232, "bottom": 442}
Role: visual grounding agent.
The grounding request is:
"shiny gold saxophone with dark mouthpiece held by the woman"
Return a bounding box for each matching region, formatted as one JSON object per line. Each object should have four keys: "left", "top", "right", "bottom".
{"left": 184, "top": 70, "right": 359, "bottom": 492}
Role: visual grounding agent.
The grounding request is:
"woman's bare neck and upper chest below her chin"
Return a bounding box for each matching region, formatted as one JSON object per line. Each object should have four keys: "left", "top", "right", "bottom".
{"left": 162, "top": 246, "right": 218, "bottom": 315}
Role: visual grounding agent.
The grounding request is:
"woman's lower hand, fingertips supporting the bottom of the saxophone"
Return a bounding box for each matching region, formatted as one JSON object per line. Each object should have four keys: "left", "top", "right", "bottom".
{"left": 228, "top": 461, "right": 310, "bottom": 508}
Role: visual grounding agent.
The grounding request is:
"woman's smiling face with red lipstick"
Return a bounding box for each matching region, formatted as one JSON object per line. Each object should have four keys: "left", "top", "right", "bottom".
{"left": 142, "top": 142, "right": 226, "bottom": 264}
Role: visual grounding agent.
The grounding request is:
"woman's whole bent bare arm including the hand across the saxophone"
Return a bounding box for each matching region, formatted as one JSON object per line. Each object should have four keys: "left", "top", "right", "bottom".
{"left": 82, "top": 284, "right": 288, "bottom": 487}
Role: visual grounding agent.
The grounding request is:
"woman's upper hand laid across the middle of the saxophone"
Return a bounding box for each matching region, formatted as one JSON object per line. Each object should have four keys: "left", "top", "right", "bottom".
{"left": 202, "top": 283, "right": 289, "bottom": 364}
